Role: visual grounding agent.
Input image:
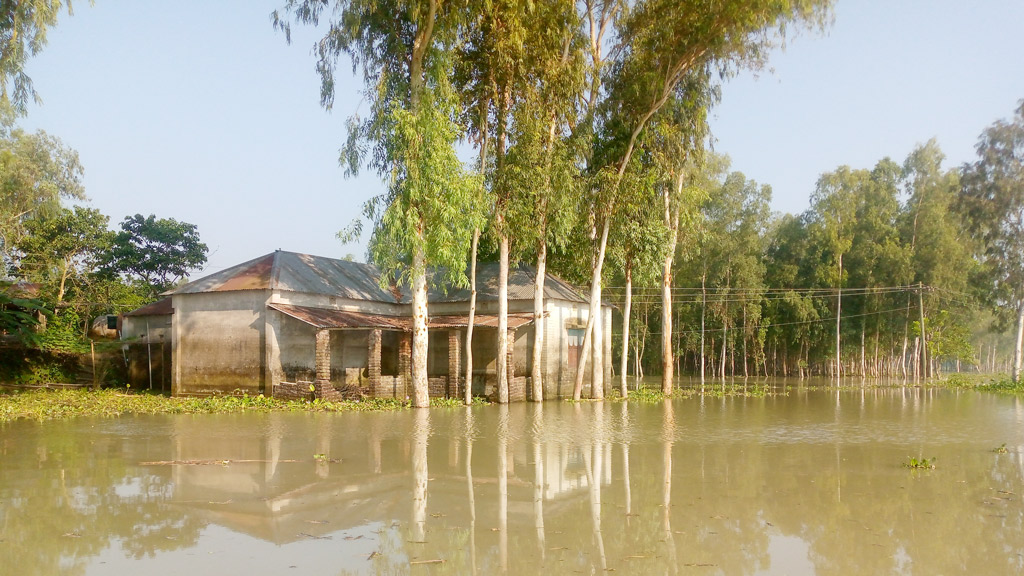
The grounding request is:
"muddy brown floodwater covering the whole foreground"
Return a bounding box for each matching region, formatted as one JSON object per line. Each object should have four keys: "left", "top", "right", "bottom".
{"left": 0, "top": 381, "right": 1024, "bottom": 575}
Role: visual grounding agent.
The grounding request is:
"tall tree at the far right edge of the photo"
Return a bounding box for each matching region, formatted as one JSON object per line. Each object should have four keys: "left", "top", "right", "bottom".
{"left": 959, "top": 99, "right": 1024, "bottom": 381}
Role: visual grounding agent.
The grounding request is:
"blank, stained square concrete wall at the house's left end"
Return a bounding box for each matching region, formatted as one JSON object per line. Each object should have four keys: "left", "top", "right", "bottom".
{"left": 171, "top": 290, "right": 270, "bottom": 396}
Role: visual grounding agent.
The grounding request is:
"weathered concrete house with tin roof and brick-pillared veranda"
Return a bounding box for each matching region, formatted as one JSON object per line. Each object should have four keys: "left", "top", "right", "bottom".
{"left": 122, "top": 250, "right": 611, "bottom": 401}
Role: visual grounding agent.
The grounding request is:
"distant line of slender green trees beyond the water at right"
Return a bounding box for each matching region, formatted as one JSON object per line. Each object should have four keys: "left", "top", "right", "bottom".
{"left": 612, "top": 131, "right": 1020, "bottom": 378}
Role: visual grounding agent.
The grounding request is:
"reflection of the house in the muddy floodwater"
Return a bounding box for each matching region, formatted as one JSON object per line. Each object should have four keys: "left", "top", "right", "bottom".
{"left": 162, "top": 404, "right": 611, "bottom": 566}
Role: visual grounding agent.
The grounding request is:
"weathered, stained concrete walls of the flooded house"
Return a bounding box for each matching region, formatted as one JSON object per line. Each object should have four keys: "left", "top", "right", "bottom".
{"left": 166, "top": 290, "right": 611, "bottom": 399}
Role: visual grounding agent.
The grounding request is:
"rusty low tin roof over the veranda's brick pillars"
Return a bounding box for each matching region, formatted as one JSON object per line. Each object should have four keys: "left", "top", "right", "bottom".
{"left": 267, "top": 304, "right": 534, "bottom": 332}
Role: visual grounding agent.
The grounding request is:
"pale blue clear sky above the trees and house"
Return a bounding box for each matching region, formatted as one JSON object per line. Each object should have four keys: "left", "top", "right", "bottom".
{"left": 14, "top": 0, "right": 1024, "bottom": 278}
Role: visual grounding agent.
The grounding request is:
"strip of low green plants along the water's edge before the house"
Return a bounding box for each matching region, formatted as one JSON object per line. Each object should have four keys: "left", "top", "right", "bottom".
{"left": 0, "top": 388, "right": 484, "bottom": 422}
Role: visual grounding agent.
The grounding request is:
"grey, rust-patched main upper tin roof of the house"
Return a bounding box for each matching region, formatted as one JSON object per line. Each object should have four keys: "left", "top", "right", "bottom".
{"left": 167, "top": 250, "right": 587, "bottom": 303}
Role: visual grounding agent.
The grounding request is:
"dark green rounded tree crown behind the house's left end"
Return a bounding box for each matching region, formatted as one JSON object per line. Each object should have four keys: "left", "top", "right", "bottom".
{"left": 102, "top": 214, "right": 208, "bottom": 298}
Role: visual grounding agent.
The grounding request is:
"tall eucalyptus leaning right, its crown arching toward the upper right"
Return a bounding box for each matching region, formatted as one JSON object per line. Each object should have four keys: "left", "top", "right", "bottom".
{"left": 573, "top": 0, "right": 830, "bottom": 398}
